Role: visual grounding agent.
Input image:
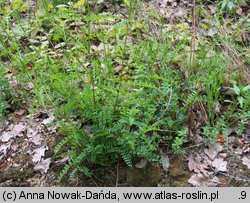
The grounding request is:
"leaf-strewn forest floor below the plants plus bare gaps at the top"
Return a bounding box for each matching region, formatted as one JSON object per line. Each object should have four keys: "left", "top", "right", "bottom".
{"left": 0, "top": 0, "right": 250, "bottom": 187}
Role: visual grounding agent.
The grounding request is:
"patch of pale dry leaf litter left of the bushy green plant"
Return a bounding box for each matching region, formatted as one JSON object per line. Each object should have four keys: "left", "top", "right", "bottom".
{"left": 0, "top": 109, "right": 57, "bottom": 185}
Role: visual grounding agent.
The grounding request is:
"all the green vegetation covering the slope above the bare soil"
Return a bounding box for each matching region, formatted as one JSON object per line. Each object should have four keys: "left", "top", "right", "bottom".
{"left": 0, "top": 0, "right": 250, "bottom": 185}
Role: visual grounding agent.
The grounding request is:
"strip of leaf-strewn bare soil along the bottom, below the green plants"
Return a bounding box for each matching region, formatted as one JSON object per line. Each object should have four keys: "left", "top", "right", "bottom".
{"left": 0, "top": 109, "right": 250, "bottom": 187}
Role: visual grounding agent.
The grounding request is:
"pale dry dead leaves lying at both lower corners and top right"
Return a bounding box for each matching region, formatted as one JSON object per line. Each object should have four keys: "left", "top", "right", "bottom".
{"left": 0, "top": 0, "right": 249, "bottom": 186}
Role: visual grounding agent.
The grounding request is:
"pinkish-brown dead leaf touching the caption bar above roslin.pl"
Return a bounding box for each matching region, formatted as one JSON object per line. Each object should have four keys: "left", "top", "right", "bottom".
{"left": 188, "top": 174, "right": 220, "bottom": 187}
